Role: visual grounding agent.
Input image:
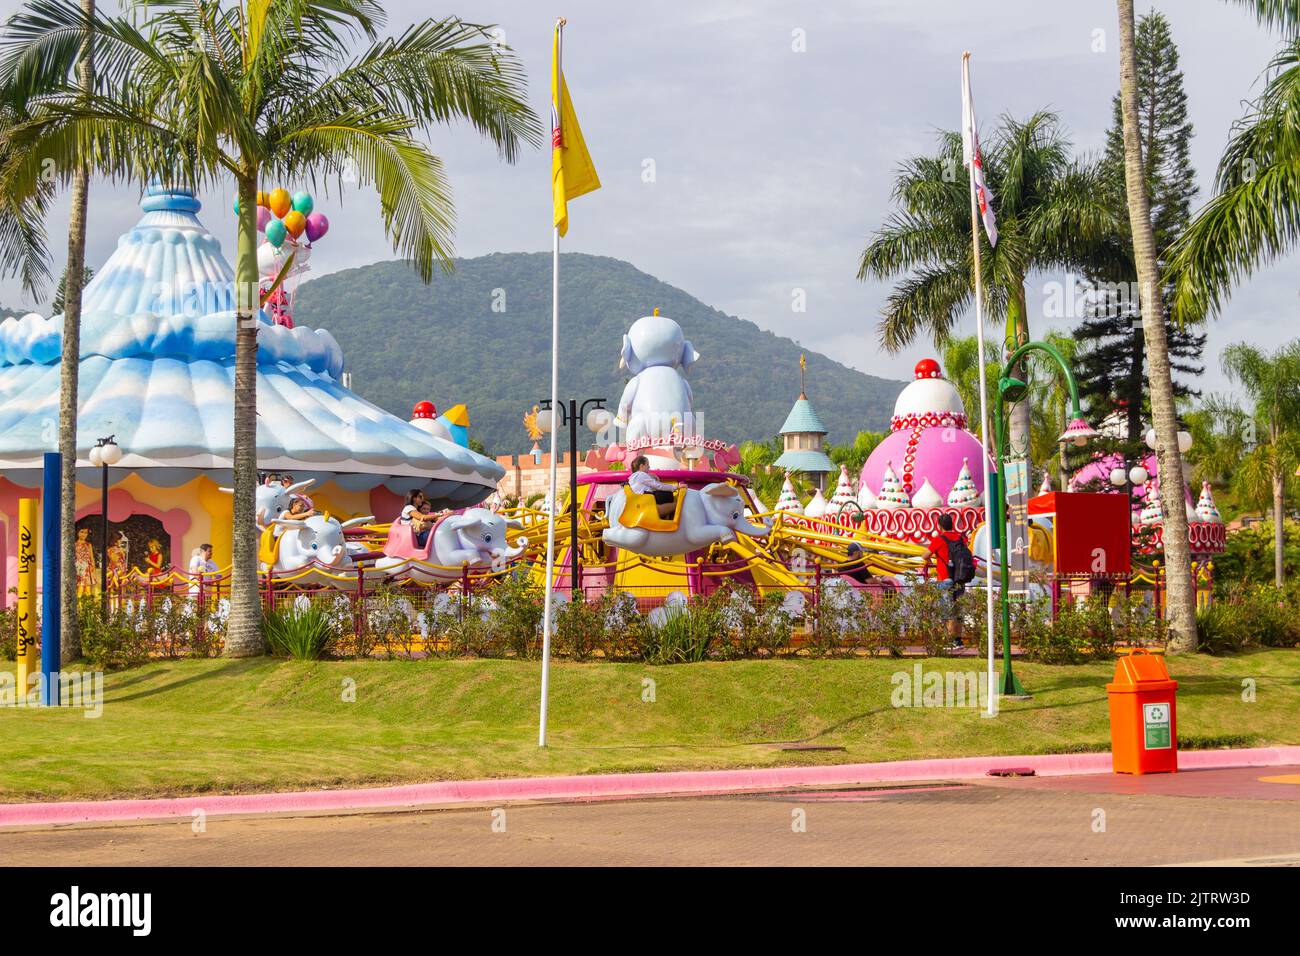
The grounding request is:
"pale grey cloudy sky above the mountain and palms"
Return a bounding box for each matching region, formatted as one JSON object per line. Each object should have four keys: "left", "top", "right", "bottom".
{"left": 0, "top": 0, "right": 1297, "bottom": 392}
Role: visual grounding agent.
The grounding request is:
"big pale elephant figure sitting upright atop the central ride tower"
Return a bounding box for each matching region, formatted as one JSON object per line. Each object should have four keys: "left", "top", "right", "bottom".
{"left": 615, "top": 315, "right": 699, "bottom": 442}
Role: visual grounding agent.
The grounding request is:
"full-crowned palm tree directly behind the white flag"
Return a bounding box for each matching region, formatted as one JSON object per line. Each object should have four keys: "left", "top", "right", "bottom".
{"left": 858, "top": 112, "right": 1117, "bottom": 481}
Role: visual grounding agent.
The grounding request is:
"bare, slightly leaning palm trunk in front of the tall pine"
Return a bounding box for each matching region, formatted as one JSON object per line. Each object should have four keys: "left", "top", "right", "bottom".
{"left": 1118, "top": 0, "right": 1196, "bottom": 653}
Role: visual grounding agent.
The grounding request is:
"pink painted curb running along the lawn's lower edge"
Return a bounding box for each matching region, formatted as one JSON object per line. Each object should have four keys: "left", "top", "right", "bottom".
{"left": 0, "top": 747, "right": 1300, "bottom": 826}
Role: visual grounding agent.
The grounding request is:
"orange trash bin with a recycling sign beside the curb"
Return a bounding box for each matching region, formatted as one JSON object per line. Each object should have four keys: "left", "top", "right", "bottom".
{"left": 1106, "top": 648, "right": 1178, "bottom": 774}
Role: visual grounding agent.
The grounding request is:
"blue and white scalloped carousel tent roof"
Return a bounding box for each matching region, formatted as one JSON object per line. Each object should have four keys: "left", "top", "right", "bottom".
{"left": 0, "top": 187, "right": 504, "bottom": 506}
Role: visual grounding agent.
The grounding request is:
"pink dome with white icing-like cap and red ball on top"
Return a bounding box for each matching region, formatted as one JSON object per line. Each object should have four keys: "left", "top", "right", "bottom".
{"left": 859, "top": 359, "right": 988, "bottom": 507}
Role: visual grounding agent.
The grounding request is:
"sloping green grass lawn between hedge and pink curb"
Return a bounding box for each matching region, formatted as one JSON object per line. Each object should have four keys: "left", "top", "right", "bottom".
{"left": 0, "top": 650, "right": 1300, "bottom": 801}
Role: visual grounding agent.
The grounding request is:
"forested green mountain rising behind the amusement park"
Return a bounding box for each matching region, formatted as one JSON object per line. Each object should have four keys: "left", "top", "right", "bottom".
{"left": 294, "top": 252, "right": 902, "bottom": 454}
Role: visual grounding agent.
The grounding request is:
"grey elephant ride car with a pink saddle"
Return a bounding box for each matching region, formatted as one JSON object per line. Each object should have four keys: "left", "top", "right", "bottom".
{"left": 374, "top": 507, "right": 528, "bottom": 581}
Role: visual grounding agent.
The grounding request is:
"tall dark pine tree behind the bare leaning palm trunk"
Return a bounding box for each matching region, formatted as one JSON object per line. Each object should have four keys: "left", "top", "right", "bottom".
{"left": 1074, "top": 12, "right": 1205, "bottom": 455}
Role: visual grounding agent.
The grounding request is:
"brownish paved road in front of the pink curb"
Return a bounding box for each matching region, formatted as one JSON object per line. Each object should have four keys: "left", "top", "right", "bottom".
{"left": 0, "top": 767, "right": 1300, "bottom": 866}
